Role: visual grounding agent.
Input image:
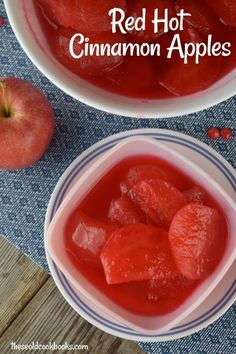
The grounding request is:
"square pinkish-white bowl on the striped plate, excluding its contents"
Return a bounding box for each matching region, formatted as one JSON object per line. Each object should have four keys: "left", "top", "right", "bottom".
{"left": 45, "top": 137, "right": 236, "bottom": 335}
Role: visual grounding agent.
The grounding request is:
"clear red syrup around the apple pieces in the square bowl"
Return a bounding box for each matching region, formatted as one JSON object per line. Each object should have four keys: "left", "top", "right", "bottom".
{"left": 64, "top": 156, "right": 228, "bottom": 316}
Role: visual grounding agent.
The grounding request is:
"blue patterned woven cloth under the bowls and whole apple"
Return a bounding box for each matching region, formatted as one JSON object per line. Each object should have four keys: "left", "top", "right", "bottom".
{"left": 0, "top": 0, "right": 236, "bottom": 354}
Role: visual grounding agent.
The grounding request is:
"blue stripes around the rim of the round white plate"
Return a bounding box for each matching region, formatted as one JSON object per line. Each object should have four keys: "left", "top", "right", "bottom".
{"left": 49, "top": 132, "right": 236, "bottom": 338}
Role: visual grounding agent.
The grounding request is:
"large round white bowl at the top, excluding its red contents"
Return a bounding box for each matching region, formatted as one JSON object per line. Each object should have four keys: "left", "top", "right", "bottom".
{"left": 4, "top": 0, "right": 236, "bottom": 118}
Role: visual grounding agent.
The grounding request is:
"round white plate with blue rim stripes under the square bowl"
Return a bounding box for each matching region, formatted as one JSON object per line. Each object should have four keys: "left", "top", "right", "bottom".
{"left": 45, "top": 129, "right": 236, "bottom": 341}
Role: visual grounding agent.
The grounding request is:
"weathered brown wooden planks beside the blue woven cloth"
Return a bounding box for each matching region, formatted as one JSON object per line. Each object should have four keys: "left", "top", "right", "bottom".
{"left": 0, "top": 237, "right": 144, "bottom": 354}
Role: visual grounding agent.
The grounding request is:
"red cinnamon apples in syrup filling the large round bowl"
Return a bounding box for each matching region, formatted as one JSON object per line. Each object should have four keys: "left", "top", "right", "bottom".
{"left": 35, "top": 0, "right": 236, "bottom": 99}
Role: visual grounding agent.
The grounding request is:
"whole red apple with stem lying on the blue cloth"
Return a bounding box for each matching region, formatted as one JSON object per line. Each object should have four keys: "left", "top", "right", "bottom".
{"left": 0, "top": 77, "right": 55, "bottom": 170}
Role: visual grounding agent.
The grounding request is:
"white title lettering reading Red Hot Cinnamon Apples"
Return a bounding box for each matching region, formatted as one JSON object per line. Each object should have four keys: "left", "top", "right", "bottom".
{"left": 69, "top": 8, "right": 231, "bottom": 64}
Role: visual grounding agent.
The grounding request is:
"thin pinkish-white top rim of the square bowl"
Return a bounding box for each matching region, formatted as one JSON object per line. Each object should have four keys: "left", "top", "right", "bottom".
{"left": 45, "top": 136, "right": 236, "bottom": 335}
